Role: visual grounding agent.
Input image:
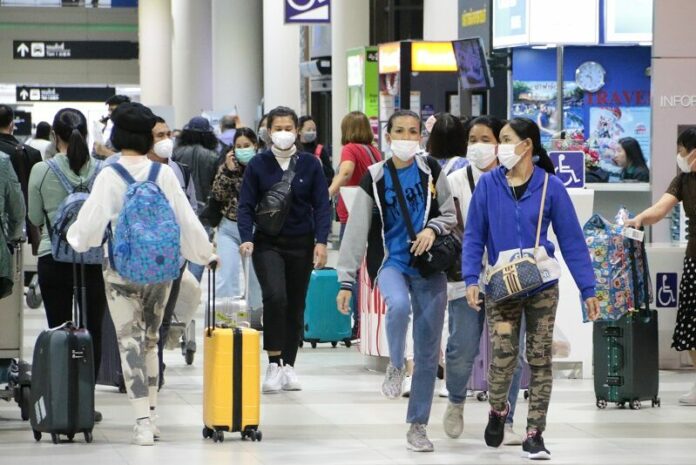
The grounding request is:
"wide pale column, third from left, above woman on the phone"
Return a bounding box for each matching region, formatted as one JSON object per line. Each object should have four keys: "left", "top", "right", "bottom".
{"left": 212, "top": 0, "right": 263, "bottom": 129}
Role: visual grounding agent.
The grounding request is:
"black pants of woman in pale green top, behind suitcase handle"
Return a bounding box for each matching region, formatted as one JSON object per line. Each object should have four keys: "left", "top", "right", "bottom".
{"left": 38, "top": 255, "right": 108, "bottom": 379}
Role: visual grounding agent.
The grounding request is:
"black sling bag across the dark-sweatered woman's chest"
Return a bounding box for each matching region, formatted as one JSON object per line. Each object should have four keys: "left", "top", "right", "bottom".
{"left": 256, "top": 156, "right": 297, "bottom": 236}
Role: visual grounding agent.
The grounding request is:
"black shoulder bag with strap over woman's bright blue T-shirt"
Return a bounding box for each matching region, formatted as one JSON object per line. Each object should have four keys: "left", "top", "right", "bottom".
{"left": 387, "top": 160, "right": 462, "bottom": 278}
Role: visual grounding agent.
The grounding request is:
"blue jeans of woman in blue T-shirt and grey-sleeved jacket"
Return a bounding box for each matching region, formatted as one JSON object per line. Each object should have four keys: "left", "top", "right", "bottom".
{"left": 377, "top": 267, "right": 447, "bottom": 425}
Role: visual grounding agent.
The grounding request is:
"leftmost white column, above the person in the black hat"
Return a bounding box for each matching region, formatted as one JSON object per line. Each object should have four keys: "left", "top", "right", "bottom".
{"left": 138, "top": 0, "right": 172, "bottom": 106}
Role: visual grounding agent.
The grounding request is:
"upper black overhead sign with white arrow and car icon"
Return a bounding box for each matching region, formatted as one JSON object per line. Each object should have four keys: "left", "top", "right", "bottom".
{"left": 12, "top": 40, "right": 138, "bottom": 60}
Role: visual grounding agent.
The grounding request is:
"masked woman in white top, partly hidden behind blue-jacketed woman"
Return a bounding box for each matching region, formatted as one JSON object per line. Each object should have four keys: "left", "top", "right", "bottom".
{"left": 442, "top": 116, "right": 522, "bottom": 446}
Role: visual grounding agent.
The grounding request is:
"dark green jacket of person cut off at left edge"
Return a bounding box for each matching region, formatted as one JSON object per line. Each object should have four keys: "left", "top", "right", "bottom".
{"left": 0, "top": 153, "right": 26, "bottom": 288}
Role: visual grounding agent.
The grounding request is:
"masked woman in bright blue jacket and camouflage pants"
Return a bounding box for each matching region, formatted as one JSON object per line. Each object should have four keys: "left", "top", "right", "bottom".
{"left": 462, "top": 118, "right": 599, "bottom": 459}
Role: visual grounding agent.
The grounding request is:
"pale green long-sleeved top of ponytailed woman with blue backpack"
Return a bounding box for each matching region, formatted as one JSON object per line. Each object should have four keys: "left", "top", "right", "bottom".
{"left": 29, "top": 153, "right": 96, "bottom": 257}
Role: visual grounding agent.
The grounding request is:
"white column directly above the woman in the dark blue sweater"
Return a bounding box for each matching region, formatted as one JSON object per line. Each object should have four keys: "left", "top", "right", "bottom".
{"left": 263, "top": 0, "right": 300, "bottom": 112}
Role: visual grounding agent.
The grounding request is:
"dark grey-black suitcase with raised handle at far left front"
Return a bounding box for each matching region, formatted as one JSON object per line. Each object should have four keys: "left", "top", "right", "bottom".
{"left": 30, "top": 258, "right": 94, "bottom": 444}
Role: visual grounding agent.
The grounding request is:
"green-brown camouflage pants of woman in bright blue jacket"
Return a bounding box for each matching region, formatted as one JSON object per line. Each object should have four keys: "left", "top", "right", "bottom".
{"left": 486, "top": 284, "right": 558, "bottom": 431}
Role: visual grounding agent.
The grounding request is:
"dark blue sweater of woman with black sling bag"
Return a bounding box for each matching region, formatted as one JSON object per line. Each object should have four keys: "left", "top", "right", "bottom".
{"left": 237, "top": 150, "right": 331, "bottom": 244}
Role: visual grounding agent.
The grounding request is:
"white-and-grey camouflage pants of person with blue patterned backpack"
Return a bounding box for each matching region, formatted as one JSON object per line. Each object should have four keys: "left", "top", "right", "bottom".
{"left": 104, "top": 268, "right": 172, "bottom": 419}
